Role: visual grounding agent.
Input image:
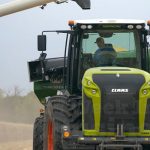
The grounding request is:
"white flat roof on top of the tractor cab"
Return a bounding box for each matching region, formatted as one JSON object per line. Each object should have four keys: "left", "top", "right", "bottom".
{"left": 75, "top": 19, "right": 145, "bottom": 24}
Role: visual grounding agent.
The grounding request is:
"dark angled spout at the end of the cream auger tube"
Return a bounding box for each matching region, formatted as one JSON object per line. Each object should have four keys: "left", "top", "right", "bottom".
{"left": 73, "top": 0, "right": 91, "bottom": 9}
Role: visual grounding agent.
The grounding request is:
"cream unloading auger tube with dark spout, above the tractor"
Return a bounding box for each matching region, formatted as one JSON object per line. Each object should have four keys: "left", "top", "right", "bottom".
{"left": 0, "top": 0, "right": 90, "bottom": 17}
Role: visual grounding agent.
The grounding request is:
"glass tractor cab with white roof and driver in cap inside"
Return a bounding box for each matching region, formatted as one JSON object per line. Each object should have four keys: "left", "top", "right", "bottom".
{"left": 68, "top": 19, "right": 149, "bottom": 92}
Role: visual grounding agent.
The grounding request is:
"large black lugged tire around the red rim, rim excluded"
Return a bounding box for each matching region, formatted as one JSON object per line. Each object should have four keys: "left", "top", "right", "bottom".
{"left": 44, "top": 96, "right": 82, "bottom": 150}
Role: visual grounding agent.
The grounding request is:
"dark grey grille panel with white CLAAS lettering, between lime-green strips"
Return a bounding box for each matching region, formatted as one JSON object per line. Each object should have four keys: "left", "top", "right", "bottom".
{"left": 93, "top": 74, "right": 145, "bottom": 132}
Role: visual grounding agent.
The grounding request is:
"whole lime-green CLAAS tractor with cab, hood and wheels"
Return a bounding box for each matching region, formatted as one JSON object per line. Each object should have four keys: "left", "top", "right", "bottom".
{"left": 28, "top": 19, "right": 150, "bottom": 150}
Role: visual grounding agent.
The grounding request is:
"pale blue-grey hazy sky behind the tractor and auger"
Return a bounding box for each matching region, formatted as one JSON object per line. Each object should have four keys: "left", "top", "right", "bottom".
{"left": 0, "top": 0, "right": 150, "bottom": 92}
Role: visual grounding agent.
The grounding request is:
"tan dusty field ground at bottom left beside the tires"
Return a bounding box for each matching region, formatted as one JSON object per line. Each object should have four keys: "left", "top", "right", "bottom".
{"left": 0, "top": 122, "right": 33, "bottom": 150}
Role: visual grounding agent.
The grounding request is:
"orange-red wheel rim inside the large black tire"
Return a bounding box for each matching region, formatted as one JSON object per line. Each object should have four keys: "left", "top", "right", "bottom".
{"left": 48, "top": 121, "right": 54, "bottom": 150}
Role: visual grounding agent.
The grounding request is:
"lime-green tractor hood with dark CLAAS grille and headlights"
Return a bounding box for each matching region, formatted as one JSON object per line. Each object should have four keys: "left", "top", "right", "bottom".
{"left": 82, "top": 67, "right": 150, "bottom": 136}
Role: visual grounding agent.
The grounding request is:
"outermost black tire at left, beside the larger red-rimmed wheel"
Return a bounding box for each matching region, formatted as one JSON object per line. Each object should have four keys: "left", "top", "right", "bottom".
{"left": 33, "top": 117, "right": 44, "bottom": 150}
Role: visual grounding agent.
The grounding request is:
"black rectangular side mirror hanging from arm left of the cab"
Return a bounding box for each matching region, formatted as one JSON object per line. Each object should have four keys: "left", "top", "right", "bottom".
{"left": 38, "top": 35, "right": 46, "bottom": 51}
